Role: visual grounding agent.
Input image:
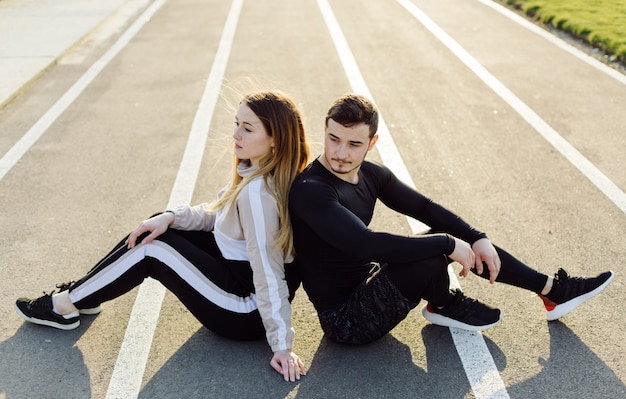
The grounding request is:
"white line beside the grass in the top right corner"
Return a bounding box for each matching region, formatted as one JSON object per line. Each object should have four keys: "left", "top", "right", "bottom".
{"left": 477, "top": 0, "right": 626, "bottom": 84}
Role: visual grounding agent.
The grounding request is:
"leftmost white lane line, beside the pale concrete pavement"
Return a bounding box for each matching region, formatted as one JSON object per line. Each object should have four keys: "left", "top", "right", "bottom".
{"left": 0, "top": 0, "right": 165, "bottom": 184}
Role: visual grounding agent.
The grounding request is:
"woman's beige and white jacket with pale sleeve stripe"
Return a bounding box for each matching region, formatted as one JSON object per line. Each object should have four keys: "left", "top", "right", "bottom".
{"left": 168, "top": 162, "right": 295, "bottom": 352}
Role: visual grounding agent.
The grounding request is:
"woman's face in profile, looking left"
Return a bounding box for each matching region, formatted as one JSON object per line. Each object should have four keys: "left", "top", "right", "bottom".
{"left": 233, "top": 104, "right": 274, "bottom": 166}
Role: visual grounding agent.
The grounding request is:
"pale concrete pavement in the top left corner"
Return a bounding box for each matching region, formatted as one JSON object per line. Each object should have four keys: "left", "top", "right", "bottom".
{"left": 0, "top": 0, "right": 147, "bottom": 108}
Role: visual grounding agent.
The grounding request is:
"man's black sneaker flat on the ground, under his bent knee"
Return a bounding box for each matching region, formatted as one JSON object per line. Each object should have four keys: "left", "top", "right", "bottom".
{"left": 422, "top": 289, "right": 502, "bottom": 331}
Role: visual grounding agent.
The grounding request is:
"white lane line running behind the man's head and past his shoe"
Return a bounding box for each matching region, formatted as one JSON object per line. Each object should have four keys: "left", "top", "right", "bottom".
{"left": 317, "top": 0, "right": 509, "bottom": 399}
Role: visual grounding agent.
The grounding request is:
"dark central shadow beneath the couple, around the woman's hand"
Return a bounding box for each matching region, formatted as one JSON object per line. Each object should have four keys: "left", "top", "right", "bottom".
{"left": 139, "top": 325, "right": 470, "bottom": 399}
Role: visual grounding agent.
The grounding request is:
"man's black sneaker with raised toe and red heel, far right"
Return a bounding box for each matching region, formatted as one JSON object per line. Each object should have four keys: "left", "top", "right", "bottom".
{"left": 539, "top": 269, "right": 615, "bottom": 321}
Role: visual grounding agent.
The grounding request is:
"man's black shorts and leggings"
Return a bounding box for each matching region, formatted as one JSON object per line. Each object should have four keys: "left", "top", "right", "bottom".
{"left": 318, "top": 247, "right": 548, "bottom": 344}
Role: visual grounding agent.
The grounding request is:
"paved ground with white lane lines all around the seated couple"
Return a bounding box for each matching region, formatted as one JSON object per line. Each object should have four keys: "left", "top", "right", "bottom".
{"left": 0, "top": 0, "right": 626, "bottom": 399}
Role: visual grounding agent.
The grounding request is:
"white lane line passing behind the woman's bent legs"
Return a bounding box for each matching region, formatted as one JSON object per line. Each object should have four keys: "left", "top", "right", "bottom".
{"left": 106, "top": 0, "right": 243, "bottom": 399}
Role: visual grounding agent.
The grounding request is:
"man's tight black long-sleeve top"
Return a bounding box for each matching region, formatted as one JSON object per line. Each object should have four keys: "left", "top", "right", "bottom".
{"left": 289, "top": 160, "right": 486, "bottom": 311}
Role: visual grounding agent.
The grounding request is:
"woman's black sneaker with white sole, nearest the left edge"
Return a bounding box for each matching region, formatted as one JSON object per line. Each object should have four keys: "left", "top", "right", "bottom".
{"left": 15, "top": 291, "right": 80, "bottom": 330}
